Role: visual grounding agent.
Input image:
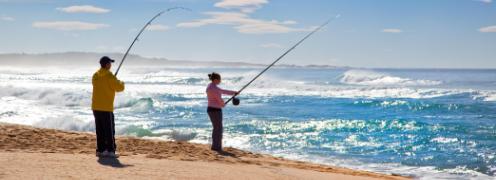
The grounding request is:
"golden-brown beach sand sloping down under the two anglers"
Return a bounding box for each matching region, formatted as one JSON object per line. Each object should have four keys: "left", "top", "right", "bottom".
{"left": 0, "top": 124, "right": 409, "bottom": 180}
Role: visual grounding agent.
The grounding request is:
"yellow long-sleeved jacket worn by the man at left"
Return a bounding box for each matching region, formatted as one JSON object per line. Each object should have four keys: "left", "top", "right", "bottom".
{"left": 91, "top": 68, "right": 124, "bottom": 112}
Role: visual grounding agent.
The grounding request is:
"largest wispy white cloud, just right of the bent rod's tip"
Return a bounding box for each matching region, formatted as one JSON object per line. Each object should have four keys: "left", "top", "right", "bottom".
{"left": 177, "top": 12, "right": 311, "bottom": 34}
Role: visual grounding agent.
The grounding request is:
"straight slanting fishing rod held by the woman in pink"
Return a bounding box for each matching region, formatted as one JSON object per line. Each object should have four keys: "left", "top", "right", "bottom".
{"left": 224, "top": 15, "right": 341, "bottom": 105}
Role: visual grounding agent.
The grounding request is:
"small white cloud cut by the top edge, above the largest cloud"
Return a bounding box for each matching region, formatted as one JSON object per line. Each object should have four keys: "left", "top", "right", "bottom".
{"left": 214, "top": 0, "right": 269, "bottom": 13}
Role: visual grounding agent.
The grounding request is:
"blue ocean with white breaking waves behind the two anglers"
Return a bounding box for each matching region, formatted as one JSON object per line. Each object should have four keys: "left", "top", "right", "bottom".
{"left": 0, "top": 66, "right": 496, "bottom": 179}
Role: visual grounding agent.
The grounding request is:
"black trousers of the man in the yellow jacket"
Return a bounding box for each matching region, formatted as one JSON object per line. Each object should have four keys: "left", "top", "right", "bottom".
{"left": 93, "top": 111, "right": 117, "bottom": 152}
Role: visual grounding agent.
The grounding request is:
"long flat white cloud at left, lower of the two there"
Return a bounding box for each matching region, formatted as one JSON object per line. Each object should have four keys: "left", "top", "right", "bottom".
{"left": 33, "top": 21, "right": 110, "bottom": 31}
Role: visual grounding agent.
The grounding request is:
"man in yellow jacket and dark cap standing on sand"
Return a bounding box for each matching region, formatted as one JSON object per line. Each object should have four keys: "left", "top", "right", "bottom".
{"left": 91, "top": 56, "right": 124, "bottom": 158}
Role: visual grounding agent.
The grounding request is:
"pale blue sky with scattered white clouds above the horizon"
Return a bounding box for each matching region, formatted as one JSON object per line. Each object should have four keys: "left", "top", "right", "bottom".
{"left": 0, "top": 0, "right": 496, "bottom": 68}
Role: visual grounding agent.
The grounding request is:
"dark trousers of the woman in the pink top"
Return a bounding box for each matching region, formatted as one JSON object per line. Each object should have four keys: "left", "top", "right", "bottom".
{"left": 207, "top": 107, "right": 223, "bottom": 151}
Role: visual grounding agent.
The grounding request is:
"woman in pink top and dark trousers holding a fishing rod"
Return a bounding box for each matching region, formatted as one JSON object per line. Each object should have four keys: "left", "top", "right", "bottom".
{"left": 206, "top": 72, "right": 238, "bottom": 151}
